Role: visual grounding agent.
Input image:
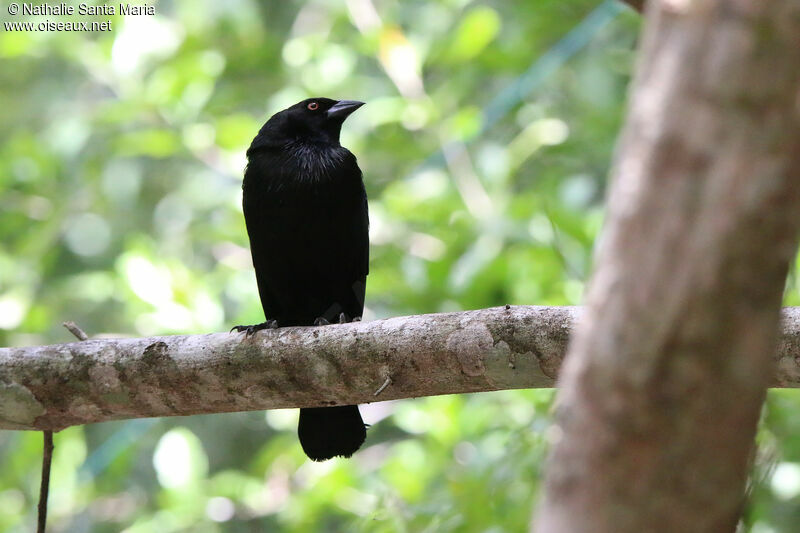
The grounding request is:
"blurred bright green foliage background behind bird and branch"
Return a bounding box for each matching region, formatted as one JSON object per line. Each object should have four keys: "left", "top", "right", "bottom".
{"left": 0, "top": 0, "right": 800, "bottom": 533}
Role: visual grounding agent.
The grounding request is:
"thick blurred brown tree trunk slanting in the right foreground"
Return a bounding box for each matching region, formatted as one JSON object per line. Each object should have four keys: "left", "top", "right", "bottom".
{"left": 535, "top": 0, "right": 800, "bottom": 533}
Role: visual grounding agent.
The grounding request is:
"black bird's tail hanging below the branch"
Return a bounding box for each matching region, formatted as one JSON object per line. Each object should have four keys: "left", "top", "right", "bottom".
{"left": 297, "top": 405, "right": 367, "bottom": 461}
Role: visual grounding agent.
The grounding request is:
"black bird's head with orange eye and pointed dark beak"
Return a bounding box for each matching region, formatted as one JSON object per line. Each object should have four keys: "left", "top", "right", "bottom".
{"left": 248, "top": 98, "right": 364, "bottom": 152}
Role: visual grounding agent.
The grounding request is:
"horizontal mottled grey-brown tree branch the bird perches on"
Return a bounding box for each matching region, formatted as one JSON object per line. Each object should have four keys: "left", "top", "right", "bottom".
{"left": 0, "top": 307, "right": 800, "bottom": 430}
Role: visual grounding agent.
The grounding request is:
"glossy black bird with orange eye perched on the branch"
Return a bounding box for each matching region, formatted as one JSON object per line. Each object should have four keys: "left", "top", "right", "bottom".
{"left": 233, "top": 98, "right": 369, "bottom": 461}
